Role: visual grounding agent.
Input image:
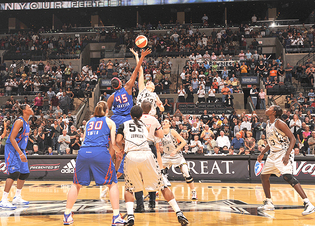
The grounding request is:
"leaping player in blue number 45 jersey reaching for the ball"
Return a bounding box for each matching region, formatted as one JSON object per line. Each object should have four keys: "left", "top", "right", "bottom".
{"left": 107, "top": 49, "right": 151, "bottom": 177}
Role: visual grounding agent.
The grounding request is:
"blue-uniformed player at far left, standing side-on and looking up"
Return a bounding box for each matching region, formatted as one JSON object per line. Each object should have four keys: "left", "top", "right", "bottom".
{"left": 0, "top": 104, "right": 34, "bottom": 209}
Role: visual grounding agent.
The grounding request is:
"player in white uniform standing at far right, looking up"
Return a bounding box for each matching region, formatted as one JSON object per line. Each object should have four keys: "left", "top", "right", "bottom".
{"left": 257, "top": 105, "right": 315, "bottom": 215}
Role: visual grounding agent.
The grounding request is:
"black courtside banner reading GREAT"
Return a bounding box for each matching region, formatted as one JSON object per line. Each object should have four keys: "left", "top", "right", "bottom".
{"left": 168, "top": 159, "right": 249, "bottom": 181}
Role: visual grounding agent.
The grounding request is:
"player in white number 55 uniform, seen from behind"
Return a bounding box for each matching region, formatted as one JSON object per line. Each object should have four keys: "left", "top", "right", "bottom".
{"left": 116, "top": 105, "right": 189, "bottom": 225}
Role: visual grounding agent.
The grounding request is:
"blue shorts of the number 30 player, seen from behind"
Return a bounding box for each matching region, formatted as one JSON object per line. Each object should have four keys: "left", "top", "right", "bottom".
{"left": 73, "top": 147, "right": 117, "bottom": 186}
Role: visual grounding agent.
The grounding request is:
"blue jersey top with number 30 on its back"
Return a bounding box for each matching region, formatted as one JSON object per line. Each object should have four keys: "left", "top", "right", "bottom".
{"left": 81, "top": 116, "right": 110, "bottom": 148}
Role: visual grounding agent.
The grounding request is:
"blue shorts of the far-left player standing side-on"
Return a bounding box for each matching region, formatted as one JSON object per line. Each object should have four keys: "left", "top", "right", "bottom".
{"left": 4, "top": 144, "right": 30, "bottom": 174}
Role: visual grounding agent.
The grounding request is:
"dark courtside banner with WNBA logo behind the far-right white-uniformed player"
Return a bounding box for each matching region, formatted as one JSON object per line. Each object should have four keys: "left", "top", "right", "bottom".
{"left": 250, "top": 158, "right": 315, "bottom": 182}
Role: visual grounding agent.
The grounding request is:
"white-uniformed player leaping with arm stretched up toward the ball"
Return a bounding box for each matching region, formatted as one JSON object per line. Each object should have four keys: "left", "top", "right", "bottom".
{"left": 134, "top": 49, "right": 164, "bottom": 116}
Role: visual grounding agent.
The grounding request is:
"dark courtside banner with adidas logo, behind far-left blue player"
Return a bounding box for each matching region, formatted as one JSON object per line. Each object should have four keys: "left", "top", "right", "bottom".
{"left": 0, "top": 158, "right": 76, "bottom": 180}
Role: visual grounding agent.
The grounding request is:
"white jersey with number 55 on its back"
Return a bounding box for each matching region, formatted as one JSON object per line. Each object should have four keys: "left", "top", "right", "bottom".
{"left": 123, "top": 120, "right": 151, "bottom": 153}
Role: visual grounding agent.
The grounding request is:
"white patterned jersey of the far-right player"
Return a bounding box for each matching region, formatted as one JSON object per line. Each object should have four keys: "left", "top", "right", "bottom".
{"left": 266, "top": 119, "right": 290, "bottom": 152}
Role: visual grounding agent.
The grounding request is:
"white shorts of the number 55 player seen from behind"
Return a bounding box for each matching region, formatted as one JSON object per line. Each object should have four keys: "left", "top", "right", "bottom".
{"left": 124, "top": 151, "right": 164, "bottom": 192}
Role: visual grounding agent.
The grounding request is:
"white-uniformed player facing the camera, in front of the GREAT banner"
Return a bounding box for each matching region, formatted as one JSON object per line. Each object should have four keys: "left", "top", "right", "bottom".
{"left": 161, "top": 119, "right": 197, "bottom": 200}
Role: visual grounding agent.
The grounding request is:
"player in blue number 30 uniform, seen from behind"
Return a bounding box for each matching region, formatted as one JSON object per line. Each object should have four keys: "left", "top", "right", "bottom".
{"left": 63, "top": 101, "right": 125, "bottom": 225}
